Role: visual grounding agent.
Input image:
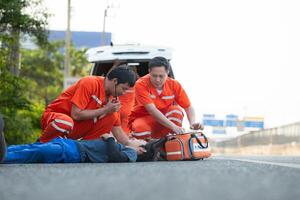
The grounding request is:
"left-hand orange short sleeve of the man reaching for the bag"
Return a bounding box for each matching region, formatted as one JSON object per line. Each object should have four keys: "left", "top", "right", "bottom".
{"left": 134, "top": 82, "right": 153, "bottom": 106}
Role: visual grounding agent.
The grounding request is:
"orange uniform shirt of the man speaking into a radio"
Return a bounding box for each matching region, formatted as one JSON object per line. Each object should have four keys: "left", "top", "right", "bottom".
{"left": 46, "top": 76, "right": 121, "bottom": 126}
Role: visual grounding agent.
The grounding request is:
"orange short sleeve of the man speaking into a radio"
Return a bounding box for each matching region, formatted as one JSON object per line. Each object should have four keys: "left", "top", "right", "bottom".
{"left": 71, "top": 77, "right": 93, "bottom": 110}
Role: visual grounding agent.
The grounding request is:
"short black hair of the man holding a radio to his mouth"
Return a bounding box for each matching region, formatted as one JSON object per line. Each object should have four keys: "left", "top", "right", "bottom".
{"left": 107, "top": 65, "right": 136, "bottom": 87}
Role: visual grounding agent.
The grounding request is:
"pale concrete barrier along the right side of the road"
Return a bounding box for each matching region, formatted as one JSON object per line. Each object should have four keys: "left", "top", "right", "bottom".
{"left": 211, "top": 122, "right": 300, "bottom": 155}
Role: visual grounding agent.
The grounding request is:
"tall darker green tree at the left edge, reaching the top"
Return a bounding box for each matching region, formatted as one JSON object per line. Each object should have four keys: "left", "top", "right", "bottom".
{"left": 0, "top": 0, "right": 48, "bottom": 144}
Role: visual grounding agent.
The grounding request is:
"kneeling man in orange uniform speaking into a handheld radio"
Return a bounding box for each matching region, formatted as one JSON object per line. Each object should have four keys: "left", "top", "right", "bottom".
{"left": 39, "top": 67, "right": 142, "bottom": 148}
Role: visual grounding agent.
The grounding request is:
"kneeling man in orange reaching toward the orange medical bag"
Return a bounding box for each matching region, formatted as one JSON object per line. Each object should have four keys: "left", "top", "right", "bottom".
{"left": 129, "top": 57, "right": 203, "bottom": 139}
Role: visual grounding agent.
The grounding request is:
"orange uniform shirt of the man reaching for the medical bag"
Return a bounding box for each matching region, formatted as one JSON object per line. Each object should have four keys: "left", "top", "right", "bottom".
{"left": 130, "top": 74, "right": 191, "bottom": 122}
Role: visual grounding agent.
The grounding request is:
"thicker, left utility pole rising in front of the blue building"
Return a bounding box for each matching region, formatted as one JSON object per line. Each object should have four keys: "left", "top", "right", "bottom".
{"left": 64, "top": 0, "right": 71, "bottom": 78}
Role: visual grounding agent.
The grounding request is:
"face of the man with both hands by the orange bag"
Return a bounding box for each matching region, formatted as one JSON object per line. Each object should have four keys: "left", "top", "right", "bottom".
{"left": 149, "top": 66, "right": 168, "bottom": 88}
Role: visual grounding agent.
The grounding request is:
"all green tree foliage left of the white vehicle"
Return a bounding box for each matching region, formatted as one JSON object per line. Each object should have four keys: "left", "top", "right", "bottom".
{"left": 0, "top": 0, "right": 90, "bottom": 144}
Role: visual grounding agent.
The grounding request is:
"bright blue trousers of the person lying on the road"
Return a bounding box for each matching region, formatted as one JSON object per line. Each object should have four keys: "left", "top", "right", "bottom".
{"left": 3, "top": 138, "right": 81, "bottom": 163}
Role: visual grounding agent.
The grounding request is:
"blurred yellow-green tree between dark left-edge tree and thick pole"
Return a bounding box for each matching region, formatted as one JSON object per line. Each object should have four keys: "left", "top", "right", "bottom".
{"left": 20, "top": 41, "right": 64, "bottom": 105}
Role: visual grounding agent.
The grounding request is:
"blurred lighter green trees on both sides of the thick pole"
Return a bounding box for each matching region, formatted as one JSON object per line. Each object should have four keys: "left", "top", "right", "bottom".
{"left": 20, "top": 41, "right": 91, "bottom": 105}
